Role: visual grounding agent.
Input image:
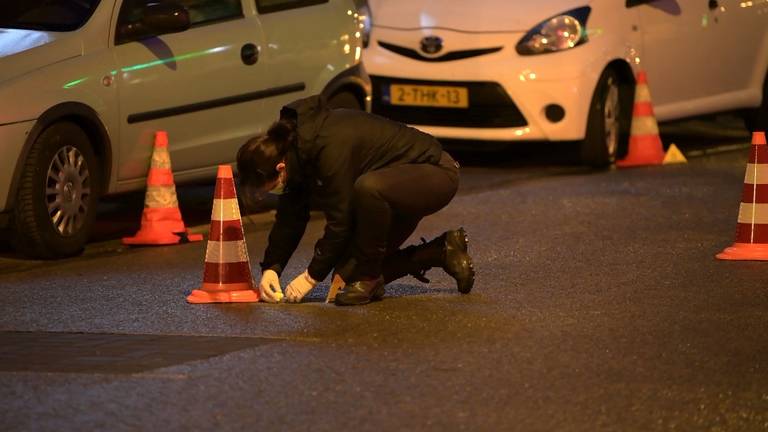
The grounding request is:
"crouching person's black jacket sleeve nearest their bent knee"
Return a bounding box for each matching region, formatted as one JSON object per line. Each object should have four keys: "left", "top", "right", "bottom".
{"left": 307, "top": 148, "right": 355, "bottom": 281}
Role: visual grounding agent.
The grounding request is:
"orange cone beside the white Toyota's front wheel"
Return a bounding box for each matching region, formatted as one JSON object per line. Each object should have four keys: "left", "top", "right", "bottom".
{"left": 616, "top": 71, "right": 666, "bottom": 168}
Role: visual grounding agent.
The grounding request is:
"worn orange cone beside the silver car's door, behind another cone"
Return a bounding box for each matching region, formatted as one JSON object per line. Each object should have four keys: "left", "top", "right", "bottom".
{"left": 123, "top": 131, "right": 203, "bottom": 245}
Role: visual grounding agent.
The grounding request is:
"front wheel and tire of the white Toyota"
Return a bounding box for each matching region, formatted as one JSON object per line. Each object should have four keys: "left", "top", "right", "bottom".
{"left": 580, "top": 69, "right": 634, "bottom": 168}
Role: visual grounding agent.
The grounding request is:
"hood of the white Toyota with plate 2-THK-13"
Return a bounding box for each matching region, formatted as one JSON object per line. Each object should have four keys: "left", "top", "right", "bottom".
{"left": 368, "top": 0, "right": 590, "bottom": 32}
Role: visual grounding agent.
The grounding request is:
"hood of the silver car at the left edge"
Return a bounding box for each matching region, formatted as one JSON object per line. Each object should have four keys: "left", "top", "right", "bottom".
{"left": 0, "top": 28, "right": 83, "bottom": 82}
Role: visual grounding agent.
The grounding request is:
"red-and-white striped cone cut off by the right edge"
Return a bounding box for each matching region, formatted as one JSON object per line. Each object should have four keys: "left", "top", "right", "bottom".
{"left": 716, "top": 132, "right": 768, "bottom": 261}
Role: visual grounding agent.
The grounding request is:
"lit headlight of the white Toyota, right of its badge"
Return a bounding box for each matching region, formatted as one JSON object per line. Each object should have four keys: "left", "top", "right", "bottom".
{"left": 516, "top": 6, "right": 592, "bottom": 55}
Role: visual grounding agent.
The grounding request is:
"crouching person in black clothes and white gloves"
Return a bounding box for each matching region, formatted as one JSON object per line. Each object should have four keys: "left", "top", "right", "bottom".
{"left": 237, "top": 96, "right": 475, "bottom": 306}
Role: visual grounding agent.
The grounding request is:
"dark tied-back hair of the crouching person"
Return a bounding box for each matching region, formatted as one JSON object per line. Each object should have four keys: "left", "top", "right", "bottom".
{"left": 237, "top": 119, "right": 296, "bottom": 189}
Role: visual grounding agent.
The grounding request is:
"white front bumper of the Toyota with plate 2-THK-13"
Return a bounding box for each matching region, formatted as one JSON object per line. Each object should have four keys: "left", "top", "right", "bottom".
{"left": 364, "top": 29, "right": 606, "bottom": 141}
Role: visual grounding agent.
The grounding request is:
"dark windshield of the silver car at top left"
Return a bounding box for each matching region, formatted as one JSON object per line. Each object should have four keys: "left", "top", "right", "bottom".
{"left": 0, "top": 0, "right": 101, "bottom": 32}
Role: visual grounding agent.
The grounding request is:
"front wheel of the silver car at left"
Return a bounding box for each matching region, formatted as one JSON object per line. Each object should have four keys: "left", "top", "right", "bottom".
{"left": 12, "top": 121, "right": 101, "bottom": 259}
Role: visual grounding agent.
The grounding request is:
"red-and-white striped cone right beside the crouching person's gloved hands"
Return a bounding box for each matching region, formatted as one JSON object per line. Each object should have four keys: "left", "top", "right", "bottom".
{"left": 187, "top": 165, "right": 259, "bottom": 303}
